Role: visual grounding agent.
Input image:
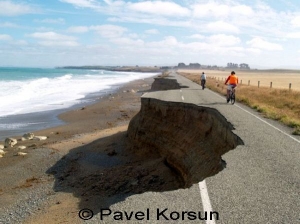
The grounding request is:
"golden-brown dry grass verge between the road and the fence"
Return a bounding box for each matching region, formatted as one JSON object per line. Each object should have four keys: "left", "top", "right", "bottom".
{"left": 180, "top": 71, "right": 300, "bottom": 135}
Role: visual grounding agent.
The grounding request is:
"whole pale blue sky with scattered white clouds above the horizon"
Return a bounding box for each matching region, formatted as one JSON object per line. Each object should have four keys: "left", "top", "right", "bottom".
{"left": 0, "top": 0, "right": 300, "bottom": 69}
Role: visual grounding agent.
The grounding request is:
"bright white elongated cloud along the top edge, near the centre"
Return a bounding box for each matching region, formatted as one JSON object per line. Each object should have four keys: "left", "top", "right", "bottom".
{"left": 127, "top": 1, "right": 190, "bottom": 17}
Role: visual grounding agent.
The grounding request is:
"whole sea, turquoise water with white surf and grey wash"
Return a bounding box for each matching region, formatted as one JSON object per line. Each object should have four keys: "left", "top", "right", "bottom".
{"left": 0, "top": 67, "right": 157, "bottom": 140}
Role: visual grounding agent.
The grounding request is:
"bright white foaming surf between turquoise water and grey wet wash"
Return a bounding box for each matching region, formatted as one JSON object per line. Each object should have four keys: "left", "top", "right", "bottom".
{"left": 0, "top": 71, "right": 155, "bottom": 117}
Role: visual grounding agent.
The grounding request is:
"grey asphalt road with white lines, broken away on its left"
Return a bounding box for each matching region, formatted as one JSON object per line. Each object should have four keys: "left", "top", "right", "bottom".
{"left": 85, "top": 73, "right": 300, "bottom": 224}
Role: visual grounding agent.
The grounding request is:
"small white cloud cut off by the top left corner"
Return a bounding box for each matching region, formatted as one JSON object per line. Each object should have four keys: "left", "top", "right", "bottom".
{"left": 0, "top": 0, "right": 34, "bottom": 16}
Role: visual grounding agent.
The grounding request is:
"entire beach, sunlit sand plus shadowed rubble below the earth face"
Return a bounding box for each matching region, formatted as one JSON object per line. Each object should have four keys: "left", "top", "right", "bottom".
{"left": 0, "top": 74, "right": 183, "bottom": 223}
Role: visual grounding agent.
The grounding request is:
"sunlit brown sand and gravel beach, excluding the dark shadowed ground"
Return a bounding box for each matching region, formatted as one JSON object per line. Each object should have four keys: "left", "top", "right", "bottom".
{"left": 0, "top": 75, "right": 156, "bottom": 223}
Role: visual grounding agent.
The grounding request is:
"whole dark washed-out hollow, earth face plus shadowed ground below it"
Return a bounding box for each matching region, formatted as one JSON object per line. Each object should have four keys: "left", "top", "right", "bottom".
{"left": 47, "top": 95, "right": 243, "bottom": 210}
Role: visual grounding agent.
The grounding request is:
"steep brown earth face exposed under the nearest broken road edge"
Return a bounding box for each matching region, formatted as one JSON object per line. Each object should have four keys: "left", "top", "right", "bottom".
{"left": 127, "top": 98, "right": 243, "bottom": 187}
